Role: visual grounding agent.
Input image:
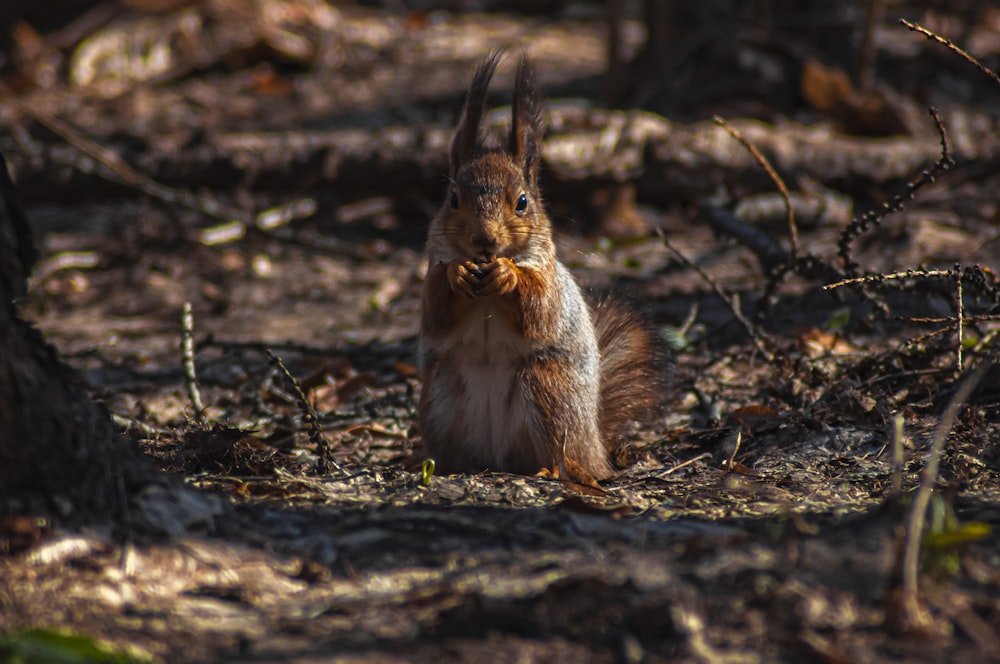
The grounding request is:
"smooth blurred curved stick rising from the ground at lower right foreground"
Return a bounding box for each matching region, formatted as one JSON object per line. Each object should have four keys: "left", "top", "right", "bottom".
{"left": 903, "top": 353, "right": 997, "bottom": 606}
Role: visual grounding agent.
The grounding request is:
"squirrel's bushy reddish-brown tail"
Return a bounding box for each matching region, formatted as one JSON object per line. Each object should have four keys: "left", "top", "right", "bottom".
{"left": 591, "top": 297, "right": 673, "bottom": 451}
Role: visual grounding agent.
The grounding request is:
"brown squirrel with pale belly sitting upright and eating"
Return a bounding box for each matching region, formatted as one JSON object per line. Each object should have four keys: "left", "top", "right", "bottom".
{"left": 419, "top": 52, "right": 662, "bottom": 479}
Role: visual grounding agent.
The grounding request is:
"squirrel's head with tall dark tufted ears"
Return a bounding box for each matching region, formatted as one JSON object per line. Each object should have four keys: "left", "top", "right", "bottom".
{"left": 438, "top": 52, "right": 551, "bottom": 259}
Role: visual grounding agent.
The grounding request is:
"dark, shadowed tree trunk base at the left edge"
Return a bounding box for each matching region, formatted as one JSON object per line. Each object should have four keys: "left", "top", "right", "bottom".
{"left": 0, "top": 155, "right": 145, "bottom": 522}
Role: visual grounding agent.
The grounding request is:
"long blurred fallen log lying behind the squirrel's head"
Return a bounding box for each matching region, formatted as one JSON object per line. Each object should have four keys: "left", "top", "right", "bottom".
{"left": 0, "top": 105, "right": 1000, "bottom": 209}
